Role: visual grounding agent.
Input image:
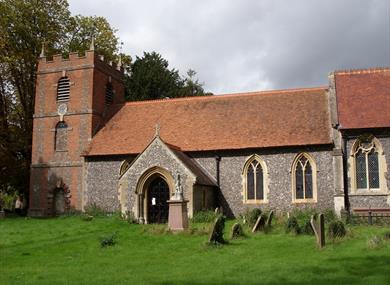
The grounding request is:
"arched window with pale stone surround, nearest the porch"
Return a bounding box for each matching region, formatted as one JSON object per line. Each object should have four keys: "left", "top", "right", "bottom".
{"left": 243, "top": 155, "right": 267, "bottom": 203}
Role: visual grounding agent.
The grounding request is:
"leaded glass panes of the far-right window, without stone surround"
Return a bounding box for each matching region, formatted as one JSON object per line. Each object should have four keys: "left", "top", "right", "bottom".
{"left": 353, "top": 136, "right": 380, "bottom": 190}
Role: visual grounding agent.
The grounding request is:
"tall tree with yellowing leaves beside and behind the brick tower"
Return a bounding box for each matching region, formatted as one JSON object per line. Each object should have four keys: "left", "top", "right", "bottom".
{"left": 0, "top": 0, "right": 126, "bottom": 199}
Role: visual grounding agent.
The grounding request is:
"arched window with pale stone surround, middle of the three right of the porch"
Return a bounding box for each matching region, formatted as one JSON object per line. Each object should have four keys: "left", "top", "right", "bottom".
{"left": 291, "top": 153, "right": 317, "bottom": 202}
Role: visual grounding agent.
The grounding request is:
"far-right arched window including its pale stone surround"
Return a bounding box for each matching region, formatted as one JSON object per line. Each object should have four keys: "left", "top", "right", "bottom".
{"left": 350, "top": 135, "right": 387, "bottom": 191}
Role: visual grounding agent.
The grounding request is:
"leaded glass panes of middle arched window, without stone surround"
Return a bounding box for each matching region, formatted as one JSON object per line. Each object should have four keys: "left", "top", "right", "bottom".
{"left": 294, "top": 154, "right": 314, "bottom": 200}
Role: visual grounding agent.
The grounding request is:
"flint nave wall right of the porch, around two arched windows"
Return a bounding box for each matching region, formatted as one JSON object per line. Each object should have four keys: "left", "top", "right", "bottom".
{"left": 190, "top": 146, "right": 334, "bottom": 216}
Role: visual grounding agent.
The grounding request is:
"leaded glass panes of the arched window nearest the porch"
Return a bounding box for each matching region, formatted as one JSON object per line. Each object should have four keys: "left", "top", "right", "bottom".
{"left": 246, "top": 159, "right": 264, "bottom": 201}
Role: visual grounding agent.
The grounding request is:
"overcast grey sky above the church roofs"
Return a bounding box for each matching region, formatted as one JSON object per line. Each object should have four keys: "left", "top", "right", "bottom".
{"left": 69, "top": 0, "right": 390, "bottom": 94}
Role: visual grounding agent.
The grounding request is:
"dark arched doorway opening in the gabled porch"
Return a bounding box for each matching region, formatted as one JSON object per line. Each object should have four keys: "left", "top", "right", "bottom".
{"left": 147, "top": 177, "right": 169, "bottom": 224}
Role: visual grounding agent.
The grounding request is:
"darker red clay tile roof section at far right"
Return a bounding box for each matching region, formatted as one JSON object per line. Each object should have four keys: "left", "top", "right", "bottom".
{"left": 335, "top": 68, "right": 390, "bottom": 129}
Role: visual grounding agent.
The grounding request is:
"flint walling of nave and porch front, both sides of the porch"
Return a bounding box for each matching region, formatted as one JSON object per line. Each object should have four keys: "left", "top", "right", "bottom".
{"left": 86, "top": 144, "right": 334, "bottom": 216}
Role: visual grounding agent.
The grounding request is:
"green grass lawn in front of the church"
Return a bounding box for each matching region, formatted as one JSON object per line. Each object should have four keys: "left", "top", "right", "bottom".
{"left": 0, "top": 216, "right": 390, "bottom": 285}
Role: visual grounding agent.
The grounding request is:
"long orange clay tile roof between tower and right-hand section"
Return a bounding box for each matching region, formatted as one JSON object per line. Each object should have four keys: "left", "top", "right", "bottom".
{"left": 86, "top": 87, "right": 332, "bottom": 156}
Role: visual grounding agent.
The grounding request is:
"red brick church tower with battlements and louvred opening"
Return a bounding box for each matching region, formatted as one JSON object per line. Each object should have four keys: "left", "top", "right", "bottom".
{"left": 29, "top": 46, "right": 124, "bottom": 216}
